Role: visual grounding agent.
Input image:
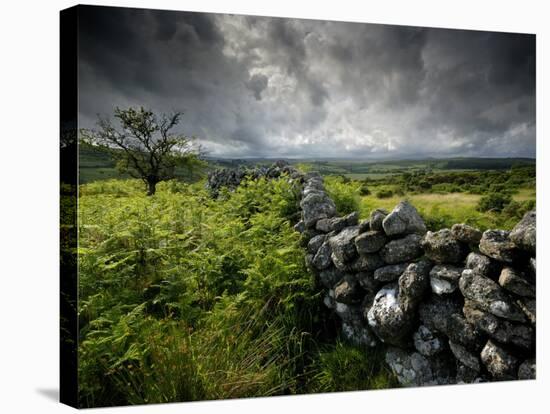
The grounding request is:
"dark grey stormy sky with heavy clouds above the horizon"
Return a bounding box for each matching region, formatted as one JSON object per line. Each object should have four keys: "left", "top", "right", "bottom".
{"left": 79, "top": 7, "right": 535, "bottom": 159}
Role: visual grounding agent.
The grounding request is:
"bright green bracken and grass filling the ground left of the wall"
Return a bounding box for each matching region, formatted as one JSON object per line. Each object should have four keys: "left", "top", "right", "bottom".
{"left": 78, "top": 179, "right": 392, "bottom": 407}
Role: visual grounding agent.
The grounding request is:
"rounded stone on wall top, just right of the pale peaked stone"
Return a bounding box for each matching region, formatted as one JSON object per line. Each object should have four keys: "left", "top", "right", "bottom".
{"left": 421, "top": 229, "right": 468, "bottom": 263}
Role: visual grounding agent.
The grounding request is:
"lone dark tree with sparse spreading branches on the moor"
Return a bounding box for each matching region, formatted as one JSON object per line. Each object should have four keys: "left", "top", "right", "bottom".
{"left": 82, "top": 107, "right": 201, "bottom": 195}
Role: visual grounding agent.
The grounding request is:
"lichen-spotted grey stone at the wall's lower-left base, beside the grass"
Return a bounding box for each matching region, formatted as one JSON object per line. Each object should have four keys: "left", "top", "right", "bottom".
{"left": 386, "top": 347, "right": 454, "bottom": 387}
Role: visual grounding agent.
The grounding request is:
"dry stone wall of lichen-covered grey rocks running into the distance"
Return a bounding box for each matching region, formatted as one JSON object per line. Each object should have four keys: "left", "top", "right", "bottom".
{"left": 207, "top": 162, "right": 536, "bottom": 386}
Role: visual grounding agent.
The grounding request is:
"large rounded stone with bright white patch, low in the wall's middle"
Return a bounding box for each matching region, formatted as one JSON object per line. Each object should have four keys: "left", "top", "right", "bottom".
{"left": 366, "top": 283, "right": 414, "bottom": 345}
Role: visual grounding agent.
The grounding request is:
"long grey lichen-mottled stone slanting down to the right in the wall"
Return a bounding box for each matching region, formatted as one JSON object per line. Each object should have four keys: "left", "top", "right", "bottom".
{"left": 458, "top": 269, "right": 525, "bottom": 322}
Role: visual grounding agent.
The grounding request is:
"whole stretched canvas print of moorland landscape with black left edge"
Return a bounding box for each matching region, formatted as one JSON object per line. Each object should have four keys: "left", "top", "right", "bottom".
{"left": 60, "top": 6, "right": 536, "bottom": 408}
